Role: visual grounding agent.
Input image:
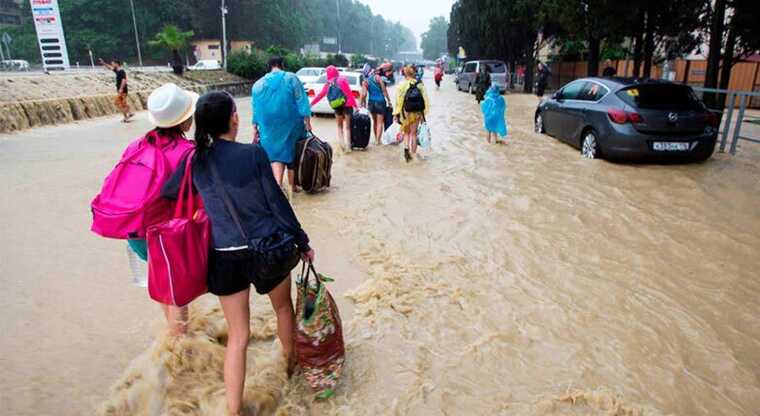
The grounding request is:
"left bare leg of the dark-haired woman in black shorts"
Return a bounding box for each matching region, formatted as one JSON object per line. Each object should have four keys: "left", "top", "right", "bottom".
{"left": 219, "top": 289, "right": 251, "bottom": 415}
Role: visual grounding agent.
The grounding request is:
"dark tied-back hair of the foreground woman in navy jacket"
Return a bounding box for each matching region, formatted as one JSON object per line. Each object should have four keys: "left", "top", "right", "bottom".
{"left": 195, "top": 91, "right": 237, "bottom": 157}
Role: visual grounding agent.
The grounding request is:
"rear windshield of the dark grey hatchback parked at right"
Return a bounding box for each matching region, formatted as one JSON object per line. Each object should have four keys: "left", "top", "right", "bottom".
{"left": 617, "top": 84, "right": 702, "bottom": 110}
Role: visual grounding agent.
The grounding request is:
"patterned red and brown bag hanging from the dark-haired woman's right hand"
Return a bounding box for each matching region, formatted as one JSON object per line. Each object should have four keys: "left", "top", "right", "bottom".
{"left": 295, "top": 263, "right": 346, "bottom": 400}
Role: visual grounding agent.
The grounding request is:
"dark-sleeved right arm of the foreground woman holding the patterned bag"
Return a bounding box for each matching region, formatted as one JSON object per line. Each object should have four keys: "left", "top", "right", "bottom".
{"left": 253, "top": 146, "right": 311, "bottom": 253}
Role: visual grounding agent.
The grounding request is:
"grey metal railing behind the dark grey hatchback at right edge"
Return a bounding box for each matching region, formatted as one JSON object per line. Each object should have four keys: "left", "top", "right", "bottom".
{"left": 692, "top": 87, "right": 760, "bottom": 155}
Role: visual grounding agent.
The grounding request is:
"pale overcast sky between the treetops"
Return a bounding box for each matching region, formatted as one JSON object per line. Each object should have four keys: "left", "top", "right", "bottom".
{"left": 359, "top": 0, "right": 454, "bottom": 46}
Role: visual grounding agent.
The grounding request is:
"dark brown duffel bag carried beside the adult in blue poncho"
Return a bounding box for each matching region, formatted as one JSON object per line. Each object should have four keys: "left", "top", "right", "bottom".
{"left": 295, "top": 132, "right": 332, "bottom": 193}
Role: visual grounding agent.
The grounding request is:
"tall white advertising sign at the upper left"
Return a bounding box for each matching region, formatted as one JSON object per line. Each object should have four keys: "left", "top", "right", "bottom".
{"left": 29, "top": 0, "right": 69, "bottom": 71}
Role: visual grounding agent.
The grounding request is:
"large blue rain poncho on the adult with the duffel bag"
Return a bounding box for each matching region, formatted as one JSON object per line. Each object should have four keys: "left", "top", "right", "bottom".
{"left": 251, "top": 71, "right": 311, "bottom": 164}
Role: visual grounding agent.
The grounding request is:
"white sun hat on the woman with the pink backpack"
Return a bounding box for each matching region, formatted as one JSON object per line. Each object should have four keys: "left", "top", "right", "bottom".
{"left": 148, "top": 83, "right": 198, "bottom": 128}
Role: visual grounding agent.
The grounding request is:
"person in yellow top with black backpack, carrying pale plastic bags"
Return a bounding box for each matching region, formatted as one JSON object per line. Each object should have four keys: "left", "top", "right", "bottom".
{"left": 393, "top": 65, "right": 430, "bottom": 162}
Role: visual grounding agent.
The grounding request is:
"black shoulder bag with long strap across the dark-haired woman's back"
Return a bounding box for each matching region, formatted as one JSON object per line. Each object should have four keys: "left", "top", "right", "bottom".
{"left": 208, "top": 160, "right": 301, "bottom": 279}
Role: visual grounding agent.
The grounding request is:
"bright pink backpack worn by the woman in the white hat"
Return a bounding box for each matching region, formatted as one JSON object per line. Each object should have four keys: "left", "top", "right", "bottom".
{"left": 90, "top": 137, "right": 193, "bottom": 240}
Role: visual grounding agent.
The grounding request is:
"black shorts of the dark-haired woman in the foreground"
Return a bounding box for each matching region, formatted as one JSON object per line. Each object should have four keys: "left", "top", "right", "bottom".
{"left": 207, "top": 249, "right": 290, "bottom": 296}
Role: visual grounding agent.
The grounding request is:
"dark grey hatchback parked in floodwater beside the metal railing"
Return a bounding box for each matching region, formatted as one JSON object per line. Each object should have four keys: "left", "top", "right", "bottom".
{"left": 534, "top": 78, "right": 718, "bottom": 161}
